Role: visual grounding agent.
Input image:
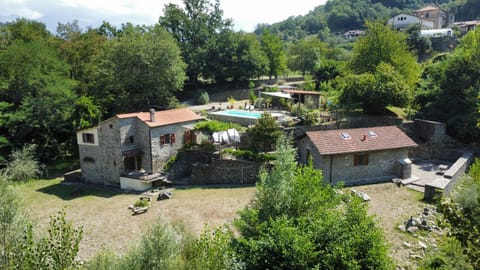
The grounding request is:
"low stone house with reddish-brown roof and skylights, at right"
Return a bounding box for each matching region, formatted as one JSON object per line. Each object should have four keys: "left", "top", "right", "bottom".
{"left": 298, "top": 126, "right": 417, "bottom": 185}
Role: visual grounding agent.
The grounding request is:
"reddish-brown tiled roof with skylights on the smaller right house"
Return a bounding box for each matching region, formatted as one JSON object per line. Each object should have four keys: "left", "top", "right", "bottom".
{"left": 307, "top": 126, "right": 417, "bottom": 155}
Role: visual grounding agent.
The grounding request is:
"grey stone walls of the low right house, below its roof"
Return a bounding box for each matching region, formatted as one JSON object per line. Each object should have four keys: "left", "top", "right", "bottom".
{"left": 298, "top": 137, "right": 408, "bottom": 185}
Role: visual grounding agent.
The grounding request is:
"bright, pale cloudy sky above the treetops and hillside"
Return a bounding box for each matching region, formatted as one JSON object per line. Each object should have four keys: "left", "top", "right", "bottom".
{"left": 0, "top": 0, "right": 326, "bottom": 32}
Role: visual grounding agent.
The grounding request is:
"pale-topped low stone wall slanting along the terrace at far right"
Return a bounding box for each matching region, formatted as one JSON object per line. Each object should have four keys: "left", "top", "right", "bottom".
{"left": 423, "top": 151, "right": 474, "bottom": 200}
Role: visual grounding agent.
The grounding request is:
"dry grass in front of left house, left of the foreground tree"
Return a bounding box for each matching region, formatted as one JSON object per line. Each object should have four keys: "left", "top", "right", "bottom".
{"left": 17, "top": 179, "right": 255, "bottom": 260}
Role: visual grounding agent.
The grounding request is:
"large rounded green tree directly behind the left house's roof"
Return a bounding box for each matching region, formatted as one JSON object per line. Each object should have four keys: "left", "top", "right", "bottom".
{"left": 100, "top": 24, "right": 186, "bottom": 113}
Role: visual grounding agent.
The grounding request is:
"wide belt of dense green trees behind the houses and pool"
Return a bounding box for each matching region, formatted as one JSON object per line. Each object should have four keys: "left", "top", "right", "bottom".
{"left": 0, "top": 0, "right": 480, "bottom": 161}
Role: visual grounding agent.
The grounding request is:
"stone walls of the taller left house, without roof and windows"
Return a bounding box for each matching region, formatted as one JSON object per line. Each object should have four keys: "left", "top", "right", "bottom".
{"left": 79, "top": 117, "right": 201, "bottom": 186}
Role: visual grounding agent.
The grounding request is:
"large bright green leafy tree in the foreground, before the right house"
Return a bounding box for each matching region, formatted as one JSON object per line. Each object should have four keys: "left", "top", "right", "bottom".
{"left": 235, "top": 137, "right": 393, "bottom": 269}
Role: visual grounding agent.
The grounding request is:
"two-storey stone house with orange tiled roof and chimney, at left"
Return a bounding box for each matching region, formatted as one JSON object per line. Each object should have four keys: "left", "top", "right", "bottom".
{"left": 77, "top": 108, "right": 203, "bottom": 188}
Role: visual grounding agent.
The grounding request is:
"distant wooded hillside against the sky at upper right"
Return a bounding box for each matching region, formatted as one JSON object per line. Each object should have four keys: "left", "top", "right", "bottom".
{"left": 255, "top": 0, "right": 480, "bottom": 41}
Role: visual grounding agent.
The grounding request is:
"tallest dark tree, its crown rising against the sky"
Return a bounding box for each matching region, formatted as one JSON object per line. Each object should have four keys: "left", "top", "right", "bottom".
{"left": 159, "top": 0, "right": 232, "bottom": 84}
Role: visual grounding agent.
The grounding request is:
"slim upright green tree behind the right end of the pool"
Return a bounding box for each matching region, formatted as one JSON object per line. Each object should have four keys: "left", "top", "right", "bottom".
{"left": 261, "top": 30, "right": 287, "bottom": 79}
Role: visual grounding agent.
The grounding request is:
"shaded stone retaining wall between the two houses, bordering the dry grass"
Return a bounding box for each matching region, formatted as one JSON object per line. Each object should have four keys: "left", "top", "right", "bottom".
{"left": 190, "top": 159, "right": 261, "bottom": 185}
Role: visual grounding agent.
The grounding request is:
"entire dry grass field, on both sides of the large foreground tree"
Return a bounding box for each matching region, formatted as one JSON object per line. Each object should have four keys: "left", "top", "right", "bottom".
{"left": 17, "top": 178, "right": 434, "bottom": 269}
